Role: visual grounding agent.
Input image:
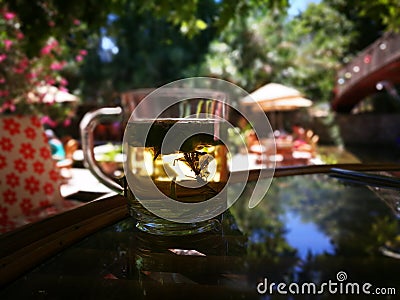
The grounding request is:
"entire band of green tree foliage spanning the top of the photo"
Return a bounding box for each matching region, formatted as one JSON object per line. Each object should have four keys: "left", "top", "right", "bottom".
{"left": 0, "top": 0, "right": 400, "bottom": 101}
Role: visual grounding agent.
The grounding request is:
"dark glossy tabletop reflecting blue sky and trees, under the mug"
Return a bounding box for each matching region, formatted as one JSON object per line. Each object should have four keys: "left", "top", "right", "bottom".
{"left": 0, "top": 174, "right": 400, "bottom": 299}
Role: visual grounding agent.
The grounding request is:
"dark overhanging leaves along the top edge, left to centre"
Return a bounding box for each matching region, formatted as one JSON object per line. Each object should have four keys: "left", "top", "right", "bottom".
{"left": 1, "top": 0, "right": 289, "bottom": 55}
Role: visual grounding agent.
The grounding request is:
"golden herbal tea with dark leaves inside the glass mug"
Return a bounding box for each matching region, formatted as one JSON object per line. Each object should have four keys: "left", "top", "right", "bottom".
{"left": 125, "top": 119, "right": 228, "bottom": 203}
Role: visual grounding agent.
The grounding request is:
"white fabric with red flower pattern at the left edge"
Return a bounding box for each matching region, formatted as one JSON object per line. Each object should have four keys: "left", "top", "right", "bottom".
{"left": 0, "top": 116, "right": 65, "bottom": 228}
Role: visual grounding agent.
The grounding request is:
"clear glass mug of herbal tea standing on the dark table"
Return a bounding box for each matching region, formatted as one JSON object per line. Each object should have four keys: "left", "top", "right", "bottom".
{"left": 81, "top": 78, "right": 272, "bottom": 236}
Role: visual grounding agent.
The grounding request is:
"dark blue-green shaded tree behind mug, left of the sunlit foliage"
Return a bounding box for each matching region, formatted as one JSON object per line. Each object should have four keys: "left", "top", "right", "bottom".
{"left": 81, "top": 0, "right": 217, "bottom": 98}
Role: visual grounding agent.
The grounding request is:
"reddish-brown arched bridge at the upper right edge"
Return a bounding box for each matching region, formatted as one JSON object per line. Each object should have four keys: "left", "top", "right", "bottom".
{"left": 332, "top": 33, "right": 400, "bottom": 112}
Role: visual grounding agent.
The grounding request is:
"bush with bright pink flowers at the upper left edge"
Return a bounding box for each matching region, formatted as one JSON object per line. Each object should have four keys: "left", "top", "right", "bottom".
{"left": 0, "top": 7, "right": 86, "bottom": 124}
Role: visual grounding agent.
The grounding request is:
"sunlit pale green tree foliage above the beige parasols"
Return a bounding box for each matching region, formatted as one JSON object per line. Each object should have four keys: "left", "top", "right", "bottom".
{"left": 199, "top": 3, "right": 354, "bottom": 101}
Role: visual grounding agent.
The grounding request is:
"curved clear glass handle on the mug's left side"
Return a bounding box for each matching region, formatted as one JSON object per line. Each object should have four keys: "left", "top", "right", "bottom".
{"left": 79, "top": 107, "right": 124, "bottom": 193}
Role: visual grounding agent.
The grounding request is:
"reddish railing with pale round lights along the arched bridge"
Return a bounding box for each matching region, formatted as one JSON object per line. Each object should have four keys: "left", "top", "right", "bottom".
{"left": 336, "top": 33, "right": 400, "bottom": 98}
